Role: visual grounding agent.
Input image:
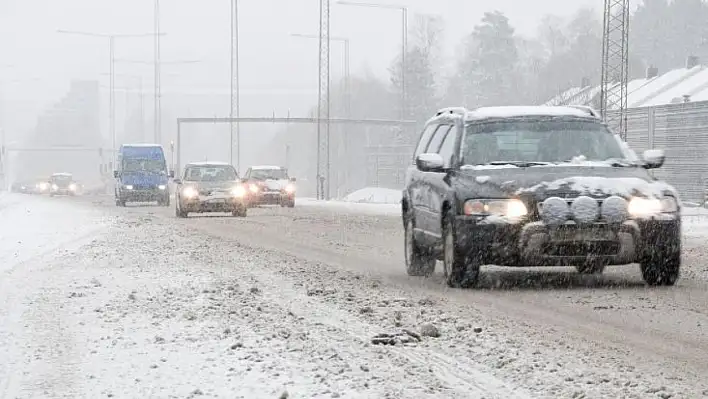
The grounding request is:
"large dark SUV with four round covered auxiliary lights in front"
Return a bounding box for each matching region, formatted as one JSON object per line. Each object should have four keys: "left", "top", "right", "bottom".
{"left": 402, "top": 107, "right": 681, "bottom": 287}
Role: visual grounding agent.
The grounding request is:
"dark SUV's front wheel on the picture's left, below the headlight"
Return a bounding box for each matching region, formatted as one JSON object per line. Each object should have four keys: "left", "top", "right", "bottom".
{"left": 443, "top": 215, "right": 481, "bottom": 288}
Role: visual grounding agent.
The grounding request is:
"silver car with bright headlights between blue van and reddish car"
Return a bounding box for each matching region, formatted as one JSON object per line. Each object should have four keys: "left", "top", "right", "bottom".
{"left": 174, "top": 162, "right": 247, "bottom": 218}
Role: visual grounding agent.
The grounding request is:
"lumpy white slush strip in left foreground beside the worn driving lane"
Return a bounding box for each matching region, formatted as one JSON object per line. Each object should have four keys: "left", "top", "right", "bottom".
{"left": 0, "top": 202, "right": 529, "bottom": 398}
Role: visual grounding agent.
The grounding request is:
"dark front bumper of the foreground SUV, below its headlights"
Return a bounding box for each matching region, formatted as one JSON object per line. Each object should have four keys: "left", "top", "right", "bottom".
{"left": 455, "top": 215, "right": 681, "bottom": 266}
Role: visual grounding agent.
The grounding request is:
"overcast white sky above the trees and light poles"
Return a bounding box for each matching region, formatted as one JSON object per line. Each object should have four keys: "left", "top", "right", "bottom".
{"left": 0, "top": 0, "right": 601, "bottom": 141}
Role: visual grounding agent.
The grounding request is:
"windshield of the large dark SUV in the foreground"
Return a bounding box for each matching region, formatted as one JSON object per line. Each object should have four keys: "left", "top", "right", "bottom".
{"left": 462, "top": 119, "right": 630, "bottom": 165}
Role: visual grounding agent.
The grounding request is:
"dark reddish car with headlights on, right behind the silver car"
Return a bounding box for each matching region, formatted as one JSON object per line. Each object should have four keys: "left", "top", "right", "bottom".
{"left": 244, "top": 166, "right": 296, "bottom": 208}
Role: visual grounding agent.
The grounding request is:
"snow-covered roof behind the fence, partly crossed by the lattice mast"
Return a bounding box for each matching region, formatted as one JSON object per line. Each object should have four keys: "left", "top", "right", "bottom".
{"left": 544, "top": 65, "right": 708, "bottom": 108}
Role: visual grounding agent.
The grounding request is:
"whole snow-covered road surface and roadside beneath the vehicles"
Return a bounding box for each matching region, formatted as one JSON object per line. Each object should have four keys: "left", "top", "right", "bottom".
{"left": 0, "top": 192, "right": 708, "bottom": 398}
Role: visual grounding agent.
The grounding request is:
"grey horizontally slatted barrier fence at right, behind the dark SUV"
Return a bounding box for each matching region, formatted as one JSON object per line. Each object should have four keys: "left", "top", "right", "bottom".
{"left": 604, "top": 101, "right": 708, "bottom": 203}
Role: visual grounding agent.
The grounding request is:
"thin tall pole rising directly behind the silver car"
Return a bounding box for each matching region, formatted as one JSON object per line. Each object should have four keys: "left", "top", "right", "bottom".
{"left": 234, "top": 0, "right": 241, "bottom": 173}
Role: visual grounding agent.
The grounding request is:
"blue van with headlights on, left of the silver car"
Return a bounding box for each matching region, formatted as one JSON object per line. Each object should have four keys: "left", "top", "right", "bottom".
{"left": 113, "top": 144, "right": 174, "bottom": 206}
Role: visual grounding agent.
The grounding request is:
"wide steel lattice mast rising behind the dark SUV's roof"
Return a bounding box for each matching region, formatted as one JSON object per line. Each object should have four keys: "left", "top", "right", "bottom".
{"left": 600, "top": 0, "right": 630, "bottom": 140}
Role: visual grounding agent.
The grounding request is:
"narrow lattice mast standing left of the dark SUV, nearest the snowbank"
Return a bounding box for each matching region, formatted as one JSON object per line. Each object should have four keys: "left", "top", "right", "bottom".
{"left": 317, "top": 0, "right": 330, "bottom": 199}
